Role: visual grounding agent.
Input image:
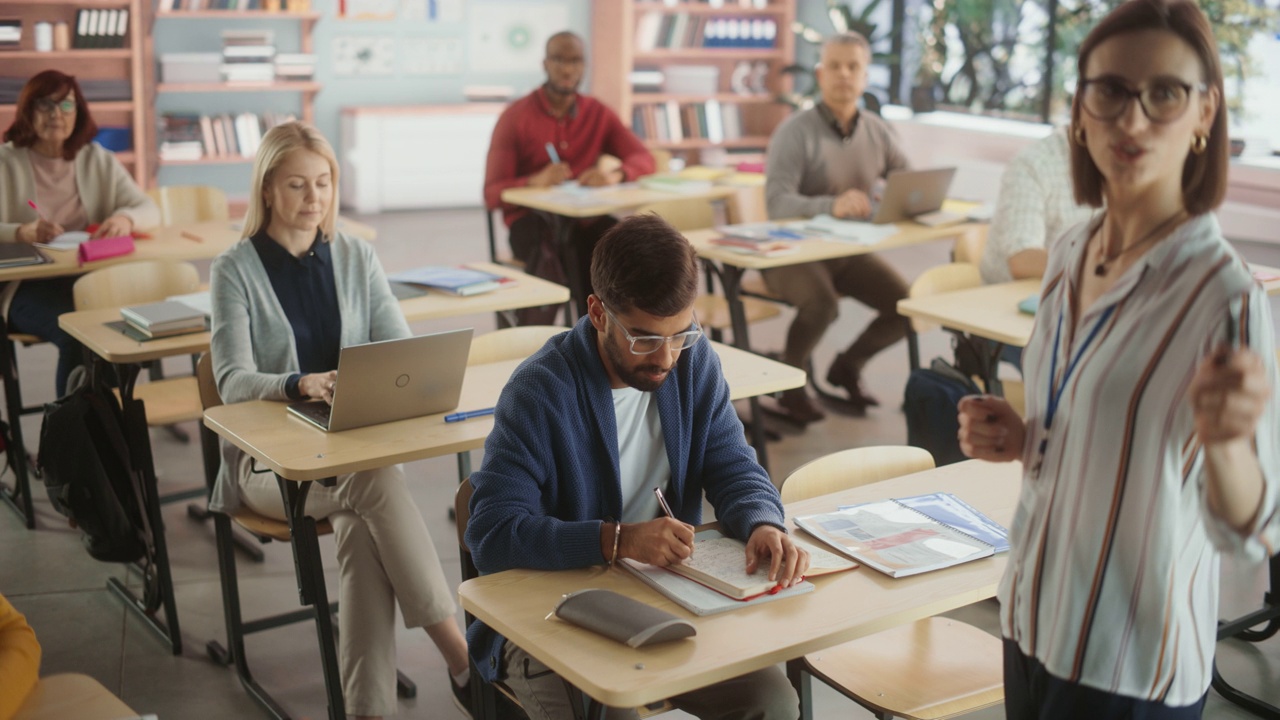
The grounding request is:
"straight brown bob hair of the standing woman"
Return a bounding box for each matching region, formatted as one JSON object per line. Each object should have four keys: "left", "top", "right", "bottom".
{"left": 1071, "top": 0, "right": 1229, "bottom": 215}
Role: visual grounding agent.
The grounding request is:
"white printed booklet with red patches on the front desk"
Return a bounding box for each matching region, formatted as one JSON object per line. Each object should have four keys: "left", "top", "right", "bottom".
{"left": 795, "top": 491, "right": 996, "bottom": 578}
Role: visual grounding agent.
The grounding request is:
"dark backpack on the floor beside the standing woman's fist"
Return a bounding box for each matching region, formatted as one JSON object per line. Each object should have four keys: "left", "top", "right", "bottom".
{"left": 904, "top": 357, "right": 982, "bottom": 466}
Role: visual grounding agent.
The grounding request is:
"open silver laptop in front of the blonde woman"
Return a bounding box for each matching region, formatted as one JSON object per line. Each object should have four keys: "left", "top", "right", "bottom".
{"left": 289, "top": 328, "right": 472, "bottom": 433}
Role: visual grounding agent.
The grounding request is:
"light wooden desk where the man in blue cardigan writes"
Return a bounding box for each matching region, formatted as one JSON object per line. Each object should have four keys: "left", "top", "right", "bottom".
{"left": 458, "top": 461, "right": 1021, "bottom": 707}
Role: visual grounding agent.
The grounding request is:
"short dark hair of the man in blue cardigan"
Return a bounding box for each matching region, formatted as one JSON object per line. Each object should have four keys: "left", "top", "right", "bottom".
{"left": 591, "top": 213, "right": 698, "bottom": 318}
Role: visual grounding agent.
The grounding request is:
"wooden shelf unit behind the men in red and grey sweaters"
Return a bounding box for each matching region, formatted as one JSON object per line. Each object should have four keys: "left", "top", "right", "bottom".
{"left": 589, "top": 0, "right": 796, "bottom": 163}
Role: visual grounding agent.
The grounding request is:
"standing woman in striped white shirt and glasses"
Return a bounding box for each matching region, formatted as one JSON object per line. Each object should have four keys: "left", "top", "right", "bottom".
{"left": 960, "top": 0, "right": 1280, "bottom": 720}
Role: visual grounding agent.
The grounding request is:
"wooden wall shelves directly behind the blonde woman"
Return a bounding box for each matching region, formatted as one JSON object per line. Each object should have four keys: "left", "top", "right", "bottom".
{"left": 148, "top": 7, "right": 324, "bottom": 168}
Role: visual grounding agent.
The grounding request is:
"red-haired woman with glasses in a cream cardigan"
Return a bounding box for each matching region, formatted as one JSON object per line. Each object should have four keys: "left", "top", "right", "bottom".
{"left": 0, "top": 70, "right": 160, "bottom": 396}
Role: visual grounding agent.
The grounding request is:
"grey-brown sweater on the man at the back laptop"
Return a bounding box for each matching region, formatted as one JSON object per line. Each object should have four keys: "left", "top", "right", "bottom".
{"left": 764, "top": 108, "right": 908, "bottom": 219}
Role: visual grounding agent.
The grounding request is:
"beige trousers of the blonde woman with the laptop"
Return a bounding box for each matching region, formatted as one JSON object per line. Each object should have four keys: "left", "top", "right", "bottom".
{"left": 239, "top": 456, "right": 454, "bottom": 715}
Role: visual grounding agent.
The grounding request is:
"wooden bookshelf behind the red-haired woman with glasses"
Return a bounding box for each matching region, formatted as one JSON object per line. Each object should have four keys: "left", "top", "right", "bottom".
{"left": 0, "top": 0, "right": 152, "bottom": 187}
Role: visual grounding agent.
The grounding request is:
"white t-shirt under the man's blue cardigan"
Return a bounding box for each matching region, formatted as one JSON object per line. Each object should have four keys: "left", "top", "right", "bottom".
{"left": 613, "top": 387, "right": 671, "bottom": 523}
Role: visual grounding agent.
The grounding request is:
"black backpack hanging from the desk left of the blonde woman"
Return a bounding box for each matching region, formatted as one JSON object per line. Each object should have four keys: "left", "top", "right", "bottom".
{"left": 40, "top": 368, "right": 147, "bottom": 562}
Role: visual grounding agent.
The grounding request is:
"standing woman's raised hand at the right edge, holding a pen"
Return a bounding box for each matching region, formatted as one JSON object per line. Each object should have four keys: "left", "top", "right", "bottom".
{"left": 1188, "top": 347, "right": 1271, "bottom": 445}
